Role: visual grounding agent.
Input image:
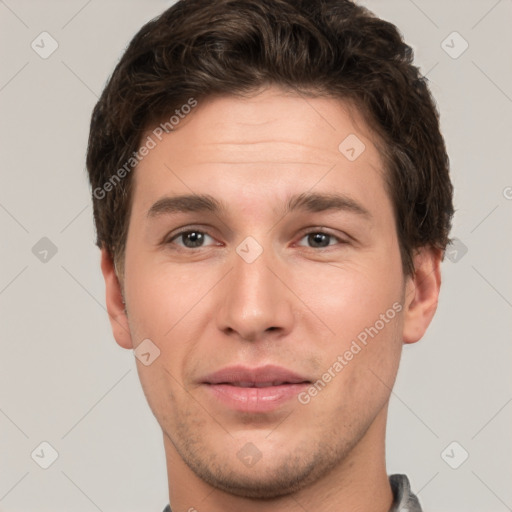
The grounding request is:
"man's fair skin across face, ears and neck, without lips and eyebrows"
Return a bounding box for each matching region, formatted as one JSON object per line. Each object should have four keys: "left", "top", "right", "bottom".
{"left": 101, "top": 87, "right": 441, "bottom": 512}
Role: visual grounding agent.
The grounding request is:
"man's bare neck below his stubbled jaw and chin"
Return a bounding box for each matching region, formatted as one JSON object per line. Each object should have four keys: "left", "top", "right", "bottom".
{"left": 164, "top": 406, "right": 393, "bottom": 512}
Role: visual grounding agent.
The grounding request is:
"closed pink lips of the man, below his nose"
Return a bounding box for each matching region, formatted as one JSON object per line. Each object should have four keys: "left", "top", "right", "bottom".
{"left": 202, "top": 365, "right": 311, "bottom": 413}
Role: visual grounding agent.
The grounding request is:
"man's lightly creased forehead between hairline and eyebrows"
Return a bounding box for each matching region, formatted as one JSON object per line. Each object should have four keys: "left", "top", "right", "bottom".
{"left": 130, "top": 87, "right": 390, "bottom": 219}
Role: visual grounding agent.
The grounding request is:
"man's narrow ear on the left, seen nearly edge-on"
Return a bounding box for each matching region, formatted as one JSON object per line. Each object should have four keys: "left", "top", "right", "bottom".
{"left": 101, "top": 248, "right": 133, "bottom": 349}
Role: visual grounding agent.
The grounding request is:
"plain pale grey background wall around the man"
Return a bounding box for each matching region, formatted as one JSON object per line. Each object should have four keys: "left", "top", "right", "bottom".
{"left": 0, "top": 0, "right": 512, "bottom": 512}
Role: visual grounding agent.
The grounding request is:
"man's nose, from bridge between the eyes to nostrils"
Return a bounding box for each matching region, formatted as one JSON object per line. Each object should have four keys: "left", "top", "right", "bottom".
{"left": 217, "top": 241, "right": 297, "bottom": 342}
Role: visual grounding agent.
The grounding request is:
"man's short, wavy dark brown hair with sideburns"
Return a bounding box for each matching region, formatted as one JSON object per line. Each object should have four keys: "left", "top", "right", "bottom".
{"left": 87, "top": 0, "right": 454, "bottom": 275}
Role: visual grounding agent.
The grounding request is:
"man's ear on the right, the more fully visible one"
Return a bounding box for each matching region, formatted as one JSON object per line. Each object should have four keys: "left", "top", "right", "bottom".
{"left": 403, "top": 247, "right": 442, "bottom": 343}
